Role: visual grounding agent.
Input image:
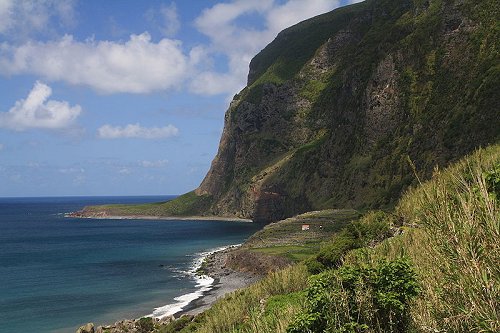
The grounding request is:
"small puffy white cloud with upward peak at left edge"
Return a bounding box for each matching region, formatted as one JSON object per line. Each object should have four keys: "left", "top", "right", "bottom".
{"left": 0, "top": 81, "right": 82, "bottom": 131}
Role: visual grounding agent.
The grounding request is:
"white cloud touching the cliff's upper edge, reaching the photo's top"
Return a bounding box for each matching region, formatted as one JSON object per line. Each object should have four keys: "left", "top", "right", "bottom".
{"left": 190, "top": 0, "right": 339, "bottom": 95}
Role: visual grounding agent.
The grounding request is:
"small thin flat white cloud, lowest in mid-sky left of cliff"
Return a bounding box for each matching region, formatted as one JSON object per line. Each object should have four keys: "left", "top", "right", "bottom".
{"left": 97, "top": 124, "right": 179, "bottom": 139}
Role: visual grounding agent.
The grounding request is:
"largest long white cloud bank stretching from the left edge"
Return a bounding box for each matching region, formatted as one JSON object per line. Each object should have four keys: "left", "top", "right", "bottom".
{"left": 0, "top": 33, "right": 189, "bottom": 93}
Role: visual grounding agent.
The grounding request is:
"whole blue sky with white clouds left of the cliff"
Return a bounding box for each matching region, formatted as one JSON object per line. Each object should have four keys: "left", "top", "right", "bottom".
{"left": 0, "top": 0, "right": 359, "bottom": 197}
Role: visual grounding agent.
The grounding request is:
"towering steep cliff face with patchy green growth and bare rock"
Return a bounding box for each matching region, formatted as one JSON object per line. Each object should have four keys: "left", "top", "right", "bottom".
{"left": 195, "top": 0, "right": 500, "bottom": 221}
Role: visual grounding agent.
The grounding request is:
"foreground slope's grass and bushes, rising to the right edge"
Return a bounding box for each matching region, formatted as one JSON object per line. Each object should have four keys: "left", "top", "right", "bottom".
{"left": 149, "top": 145, "right": 500, "bottom": 333}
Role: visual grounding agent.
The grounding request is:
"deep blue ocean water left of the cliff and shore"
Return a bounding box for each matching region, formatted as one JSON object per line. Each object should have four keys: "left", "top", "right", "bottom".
{"left": 0, "top": 197, "right": 262, "bottom": 333}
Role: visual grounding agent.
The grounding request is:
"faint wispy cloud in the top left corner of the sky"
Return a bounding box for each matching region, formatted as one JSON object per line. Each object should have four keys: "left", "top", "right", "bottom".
{"left": 0, "top": 0, "right": 76, "bottom": 40}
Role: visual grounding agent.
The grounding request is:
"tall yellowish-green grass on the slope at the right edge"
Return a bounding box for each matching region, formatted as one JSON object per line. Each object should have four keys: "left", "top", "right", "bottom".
{"left": 346, "top": 145, "right": 500, "bottom": 332}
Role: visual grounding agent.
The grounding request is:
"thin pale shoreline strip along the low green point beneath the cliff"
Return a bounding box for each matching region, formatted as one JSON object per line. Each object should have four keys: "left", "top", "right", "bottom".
{"left": 64, "top": 212, "right": 253, "bottom": 222}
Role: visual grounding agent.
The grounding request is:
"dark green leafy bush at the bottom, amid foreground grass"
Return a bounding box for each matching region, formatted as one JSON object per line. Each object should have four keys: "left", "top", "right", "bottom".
{"left": 287, "top": 258, "right": 420, "bottom": 333}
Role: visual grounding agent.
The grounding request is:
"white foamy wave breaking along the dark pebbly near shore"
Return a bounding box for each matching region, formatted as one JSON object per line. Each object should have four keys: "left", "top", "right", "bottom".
{"left": 147, "top": 244, "right": 241, "bottom": 319}
